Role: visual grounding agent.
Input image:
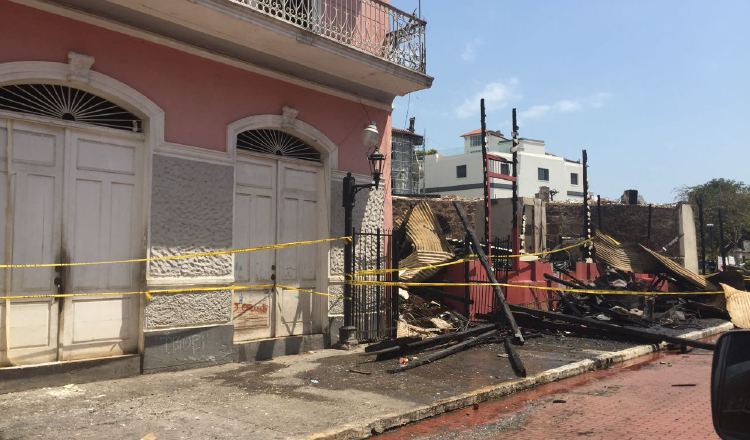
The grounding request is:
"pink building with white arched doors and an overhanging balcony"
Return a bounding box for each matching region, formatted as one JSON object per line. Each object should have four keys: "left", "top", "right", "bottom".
{"left": 0, "top": 0, "right": 432, "bottom": 376}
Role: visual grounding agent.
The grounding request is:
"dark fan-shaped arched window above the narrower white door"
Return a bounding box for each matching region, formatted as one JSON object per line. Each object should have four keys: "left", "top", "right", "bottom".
{"left": 237, "top": 128, "right": 321, "bottom": 162}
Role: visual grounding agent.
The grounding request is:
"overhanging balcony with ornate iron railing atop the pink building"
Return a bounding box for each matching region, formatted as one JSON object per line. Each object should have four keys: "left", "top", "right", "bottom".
{"left": 37, "top": 0, "right": 433, "bottom": 101}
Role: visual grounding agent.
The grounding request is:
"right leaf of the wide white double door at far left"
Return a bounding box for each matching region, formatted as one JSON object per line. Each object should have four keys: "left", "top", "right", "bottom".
{"left": 61, "top": 131, "right": 143, "bottom": 360}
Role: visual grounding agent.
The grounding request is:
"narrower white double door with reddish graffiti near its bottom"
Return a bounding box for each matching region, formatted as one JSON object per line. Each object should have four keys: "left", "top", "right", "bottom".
{"left": 233, "top": 156, "right": 321, "bottom": 341}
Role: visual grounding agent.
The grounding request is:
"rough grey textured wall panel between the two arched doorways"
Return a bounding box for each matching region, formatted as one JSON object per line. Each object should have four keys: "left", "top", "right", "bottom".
{"left": 144, "top": 154, "right": 234, "bottom": 329}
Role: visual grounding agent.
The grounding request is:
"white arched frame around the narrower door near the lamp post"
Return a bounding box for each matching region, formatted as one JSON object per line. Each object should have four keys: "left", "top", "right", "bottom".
{"left": 227, "top": 112, "right": 339, "bottom": 333}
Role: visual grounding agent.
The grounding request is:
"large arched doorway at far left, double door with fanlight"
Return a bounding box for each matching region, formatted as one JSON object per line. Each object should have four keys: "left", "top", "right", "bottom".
{"left": 0, "top": 75, "right": 157, "bottom": 365}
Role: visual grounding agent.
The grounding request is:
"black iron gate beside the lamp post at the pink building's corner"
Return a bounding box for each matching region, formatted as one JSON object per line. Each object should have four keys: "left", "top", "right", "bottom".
{"left": 352, "top": 228, "right": 399, "bottom": 342}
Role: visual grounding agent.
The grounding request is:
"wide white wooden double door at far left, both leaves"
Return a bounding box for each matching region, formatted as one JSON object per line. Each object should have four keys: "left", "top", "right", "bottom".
{"left": 0, "top": 121, "right": 144, "bottom": 365}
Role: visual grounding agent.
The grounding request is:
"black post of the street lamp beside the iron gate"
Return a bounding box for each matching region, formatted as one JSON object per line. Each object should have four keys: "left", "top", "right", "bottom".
{"left": 339, "top": 173, "right": 357, "bottom": 348}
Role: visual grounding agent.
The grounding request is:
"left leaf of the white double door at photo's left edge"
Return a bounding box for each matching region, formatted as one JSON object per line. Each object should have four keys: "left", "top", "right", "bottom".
{"left": 0, "top": 121, "right": 65, "bottom": 365}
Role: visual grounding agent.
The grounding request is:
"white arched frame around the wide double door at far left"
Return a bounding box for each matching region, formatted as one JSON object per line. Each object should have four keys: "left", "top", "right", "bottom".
{"left": 0, "top": 60, "right": 165, "bottom": 362}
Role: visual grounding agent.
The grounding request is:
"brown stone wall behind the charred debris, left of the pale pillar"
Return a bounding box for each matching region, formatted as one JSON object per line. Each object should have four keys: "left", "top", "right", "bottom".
{"left": 547, "top": 201, "right": 682, "bottom": 258}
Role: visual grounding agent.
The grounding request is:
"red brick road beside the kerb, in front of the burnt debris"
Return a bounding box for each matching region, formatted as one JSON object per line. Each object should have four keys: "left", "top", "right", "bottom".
{"left": 380, "top": 350, "right": 718, "bottom": 440}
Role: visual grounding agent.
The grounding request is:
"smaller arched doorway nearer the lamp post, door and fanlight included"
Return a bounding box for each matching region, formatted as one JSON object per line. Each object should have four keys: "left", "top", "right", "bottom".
{"left": 232, "top": 116, "right": 335, "bottom": 342}
